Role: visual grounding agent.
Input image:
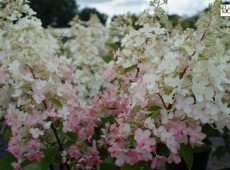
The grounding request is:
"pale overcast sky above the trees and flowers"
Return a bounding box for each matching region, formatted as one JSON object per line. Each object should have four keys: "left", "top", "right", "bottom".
{"left": 77, "top": 0, "right": 230, "bottom": 17}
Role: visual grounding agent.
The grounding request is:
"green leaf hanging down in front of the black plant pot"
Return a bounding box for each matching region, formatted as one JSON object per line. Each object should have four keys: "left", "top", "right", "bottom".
{"left": 179, "top": 144, "right": 193, "bottom": 170}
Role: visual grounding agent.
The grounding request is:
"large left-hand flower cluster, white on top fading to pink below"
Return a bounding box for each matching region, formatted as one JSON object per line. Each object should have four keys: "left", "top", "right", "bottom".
{"left": 0, "top": 0, "right": 98, "bottom": 169}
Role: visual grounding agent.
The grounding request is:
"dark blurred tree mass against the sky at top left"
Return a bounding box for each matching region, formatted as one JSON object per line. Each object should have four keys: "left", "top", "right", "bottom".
{"left": 30, "top": 0, "right": 108, "bottom": 28}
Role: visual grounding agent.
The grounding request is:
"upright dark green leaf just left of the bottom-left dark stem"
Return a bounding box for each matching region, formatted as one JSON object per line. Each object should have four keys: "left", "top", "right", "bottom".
{"left": 41, "top": 148, "right": 58, "bottom": 170}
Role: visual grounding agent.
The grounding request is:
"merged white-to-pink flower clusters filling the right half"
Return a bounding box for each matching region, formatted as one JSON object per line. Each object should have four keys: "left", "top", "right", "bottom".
{"left": 102, "top": 0, "right": 230, "bottom": 169}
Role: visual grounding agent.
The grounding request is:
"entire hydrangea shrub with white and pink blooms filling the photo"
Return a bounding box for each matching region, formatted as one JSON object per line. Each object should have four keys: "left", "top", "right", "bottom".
{"left": 0, "top": 0, "right": 230, "bottom": 170}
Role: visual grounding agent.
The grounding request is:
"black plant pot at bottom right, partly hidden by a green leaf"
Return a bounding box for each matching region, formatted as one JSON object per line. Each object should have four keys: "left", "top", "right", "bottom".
{"left": 166, "top": 145, "right": 211, "bottom": 170}
